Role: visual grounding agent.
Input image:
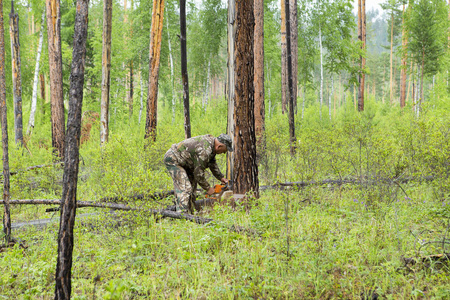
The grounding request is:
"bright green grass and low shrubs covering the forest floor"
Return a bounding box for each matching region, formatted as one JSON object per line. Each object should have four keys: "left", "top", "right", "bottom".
{"left": 0, "top": 95, "right": 450, "bottom": 299}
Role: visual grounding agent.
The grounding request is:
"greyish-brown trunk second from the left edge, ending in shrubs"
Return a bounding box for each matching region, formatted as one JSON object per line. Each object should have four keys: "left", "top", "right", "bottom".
{"left": 9, "top": 1, "right": 23, "bottom": 145}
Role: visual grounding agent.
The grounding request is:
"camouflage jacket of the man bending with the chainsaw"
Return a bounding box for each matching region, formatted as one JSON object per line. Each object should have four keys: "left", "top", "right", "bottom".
{"left": 170, "top": 134, "right": 224, "bottom": 190}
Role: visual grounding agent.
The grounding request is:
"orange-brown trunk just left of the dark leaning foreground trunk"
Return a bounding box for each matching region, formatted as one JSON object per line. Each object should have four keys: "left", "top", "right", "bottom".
{"left": 46, "top": 0, "right": 65, "bottom": 159}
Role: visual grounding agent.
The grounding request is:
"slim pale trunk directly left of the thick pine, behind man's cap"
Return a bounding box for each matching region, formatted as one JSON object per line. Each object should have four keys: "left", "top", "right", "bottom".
{"left": 227, "top": 0, "right": 236, "bottom": 179}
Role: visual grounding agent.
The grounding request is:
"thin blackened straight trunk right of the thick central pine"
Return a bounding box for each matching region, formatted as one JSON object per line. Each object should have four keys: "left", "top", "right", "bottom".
{"left": 285, "top": 0, "right": 297, "bottom": 155}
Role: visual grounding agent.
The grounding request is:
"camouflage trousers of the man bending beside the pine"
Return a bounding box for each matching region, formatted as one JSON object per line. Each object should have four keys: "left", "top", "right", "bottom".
{"left": 164, "top": 149, "right": 197, "bottom": 213}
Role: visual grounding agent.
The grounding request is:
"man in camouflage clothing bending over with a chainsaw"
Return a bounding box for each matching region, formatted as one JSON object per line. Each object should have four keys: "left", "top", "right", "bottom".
{"left": 164, "top": 134, "right": 233, "bottom": 213}
